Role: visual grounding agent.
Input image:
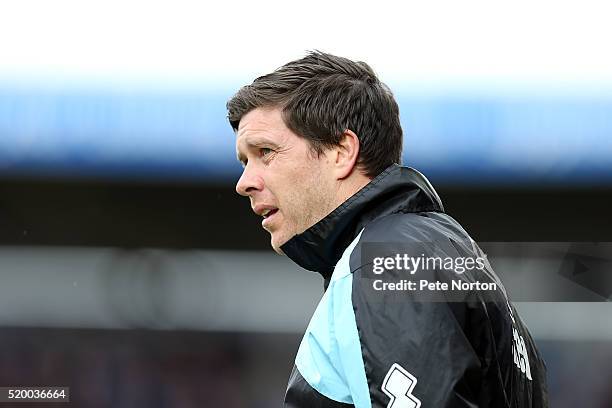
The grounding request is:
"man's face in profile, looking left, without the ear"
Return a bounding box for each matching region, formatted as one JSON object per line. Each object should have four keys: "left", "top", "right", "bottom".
{"left": 236, "top": 108, "right": 336, "bottom": 253}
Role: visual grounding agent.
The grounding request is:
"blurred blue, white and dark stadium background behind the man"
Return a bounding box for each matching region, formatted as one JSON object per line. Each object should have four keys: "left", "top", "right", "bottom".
{"left": 0, "top": 0, "right": 612, "bottom": 408}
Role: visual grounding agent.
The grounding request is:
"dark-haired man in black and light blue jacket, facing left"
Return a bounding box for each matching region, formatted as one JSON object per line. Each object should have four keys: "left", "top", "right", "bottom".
{"left": 227, "top": 52, "right": 547, "bottom": 408}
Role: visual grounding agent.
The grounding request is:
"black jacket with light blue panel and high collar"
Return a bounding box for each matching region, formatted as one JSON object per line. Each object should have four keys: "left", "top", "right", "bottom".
{"left": 282, "top": 165, "right": 548, "bottom": 408}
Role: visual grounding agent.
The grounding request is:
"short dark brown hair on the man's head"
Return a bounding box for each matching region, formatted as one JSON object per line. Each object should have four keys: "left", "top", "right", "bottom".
{"left": 227, "top": 51, "right": 403, "bottom": 177}
